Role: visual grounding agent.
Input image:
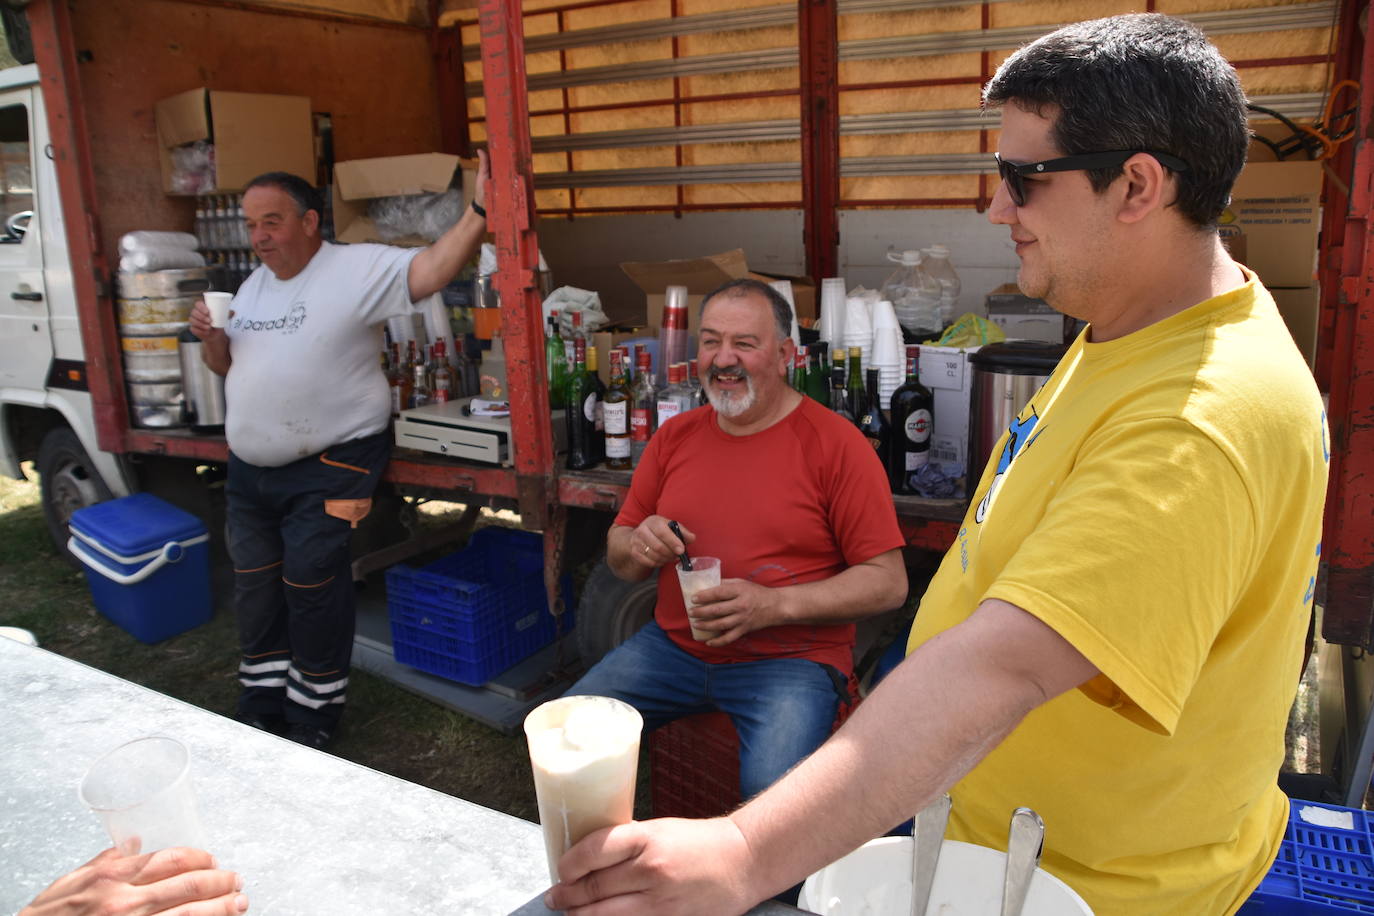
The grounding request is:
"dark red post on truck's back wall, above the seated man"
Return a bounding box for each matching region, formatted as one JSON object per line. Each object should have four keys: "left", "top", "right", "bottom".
{"left": 797, "top": 0, "right": 840, "bottom": 286}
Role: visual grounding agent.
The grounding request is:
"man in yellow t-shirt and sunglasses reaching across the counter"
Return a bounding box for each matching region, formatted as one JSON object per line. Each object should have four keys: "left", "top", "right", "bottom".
{"left": 547, "top": 14, "right": 1327, "bottom": 916}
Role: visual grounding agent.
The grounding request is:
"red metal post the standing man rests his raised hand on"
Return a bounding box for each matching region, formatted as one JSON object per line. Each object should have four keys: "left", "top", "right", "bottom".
{"left": 478, "top": 0, "right": 555, "bottom": 529}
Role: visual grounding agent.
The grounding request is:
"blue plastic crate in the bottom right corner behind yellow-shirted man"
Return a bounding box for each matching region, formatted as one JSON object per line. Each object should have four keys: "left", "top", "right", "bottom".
{"left": 1239, "top": 798, "right": 1374, "bottom": 916}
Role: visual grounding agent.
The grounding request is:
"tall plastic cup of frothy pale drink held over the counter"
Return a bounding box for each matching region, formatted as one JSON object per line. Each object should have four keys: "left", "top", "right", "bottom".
{"left": 525, "top": 696, "right": 644, "bottom": 883}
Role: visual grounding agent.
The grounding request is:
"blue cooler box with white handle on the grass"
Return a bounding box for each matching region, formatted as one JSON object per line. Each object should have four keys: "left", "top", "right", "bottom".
{"left": 67, "top": 493, "right": 212, "bottom": 643}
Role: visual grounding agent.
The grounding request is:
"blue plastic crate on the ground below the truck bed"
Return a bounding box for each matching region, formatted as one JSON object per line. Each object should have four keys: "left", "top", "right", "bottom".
{"left": 386, "top": 527, "right": 573, "bottom": 687}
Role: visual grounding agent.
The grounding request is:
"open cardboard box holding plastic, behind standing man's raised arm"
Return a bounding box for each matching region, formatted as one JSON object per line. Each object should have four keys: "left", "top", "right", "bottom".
{"left": 334, "top": 152, "right": 477, "bottom": 246}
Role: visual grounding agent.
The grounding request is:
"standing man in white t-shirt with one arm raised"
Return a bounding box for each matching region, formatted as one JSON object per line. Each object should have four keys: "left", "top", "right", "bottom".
{"left": 191, "top": 152, "right": 489, "bottom": 748}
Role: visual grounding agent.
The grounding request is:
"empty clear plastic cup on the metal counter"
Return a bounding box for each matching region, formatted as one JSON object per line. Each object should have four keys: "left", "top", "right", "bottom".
{"left": 80, "top": 736, "right": 205, "bottom": 854}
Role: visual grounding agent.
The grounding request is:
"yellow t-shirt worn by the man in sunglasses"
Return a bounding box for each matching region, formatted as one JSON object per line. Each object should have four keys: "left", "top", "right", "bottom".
{"left": 908, "top": 272, "right": 1327, "bottom": 916}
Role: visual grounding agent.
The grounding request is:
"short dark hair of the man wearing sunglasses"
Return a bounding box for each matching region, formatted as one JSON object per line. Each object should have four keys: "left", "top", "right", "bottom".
{"left": 982, "top": 12, "right": 1250, "bottom": 228}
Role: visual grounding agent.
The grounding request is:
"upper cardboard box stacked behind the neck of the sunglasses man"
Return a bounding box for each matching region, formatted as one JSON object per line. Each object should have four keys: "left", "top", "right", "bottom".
{"left": 1220, "top": 162, "right": 1322, "bottom": 288}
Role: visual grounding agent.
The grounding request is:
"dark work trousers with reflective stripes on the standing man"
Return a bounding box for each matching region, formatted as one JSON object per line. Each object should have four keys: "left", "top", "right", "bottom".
{"left": 225, "top": 433, "right": 392, "bottom": 731}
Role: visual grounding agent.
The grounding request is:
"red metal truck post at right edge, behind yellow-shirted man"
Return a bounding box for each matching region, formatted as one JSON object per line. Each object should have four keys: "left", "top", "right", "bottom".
{"left": 1322, "top": 3, "right": 1374, "bottom": 648}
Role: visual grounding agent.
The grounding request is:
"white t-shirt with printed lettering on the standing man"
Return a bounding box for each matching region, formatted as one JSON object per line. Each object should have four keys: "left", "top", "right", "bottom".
{"left": 224, "top": 242, "right": 419, "bottom": 467}
